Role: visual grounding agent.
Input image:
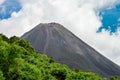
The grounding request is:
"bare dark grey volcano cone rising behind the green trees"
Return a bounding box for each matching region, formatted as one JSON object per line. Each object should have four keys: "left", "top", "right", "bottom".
{"left": 22, "top": 23, "right": 120, "bottom": 77}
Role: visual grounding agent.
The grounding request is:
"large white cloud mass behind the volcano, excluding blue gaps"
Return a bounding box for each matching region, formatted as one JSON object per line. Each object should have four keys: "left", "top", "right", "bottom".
{"left": 0, "top": 0, "right": 120, "bottom": 65}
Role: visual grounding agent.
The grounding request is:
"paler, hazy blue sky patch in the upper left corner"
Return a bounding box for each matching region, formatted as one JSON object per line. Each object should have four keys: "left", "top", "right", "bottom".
{"left": 0, "top": 0, "right": 22, "bottom": 20}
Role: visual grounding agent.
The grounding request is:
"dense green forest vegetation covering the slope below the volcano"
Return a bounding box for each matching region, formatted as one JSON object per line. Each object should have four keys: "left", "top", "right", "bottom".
{"left": 0, "top": 34, "right": 119, "bottom": 80}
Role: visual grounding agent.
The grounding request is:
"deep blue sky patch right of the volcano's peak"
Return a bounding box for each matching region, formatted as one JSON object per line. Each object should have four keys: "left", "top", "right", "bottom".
{"left": 98, "top": 4, "right": 120, "bottom": 33}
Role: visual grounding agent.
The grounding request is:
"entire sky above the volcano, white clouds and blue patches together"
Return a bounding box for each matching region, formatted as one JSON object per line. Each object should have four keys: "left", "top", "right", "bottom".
{"left": 0, "top": 0, "right": 120, "bottom": 65}
